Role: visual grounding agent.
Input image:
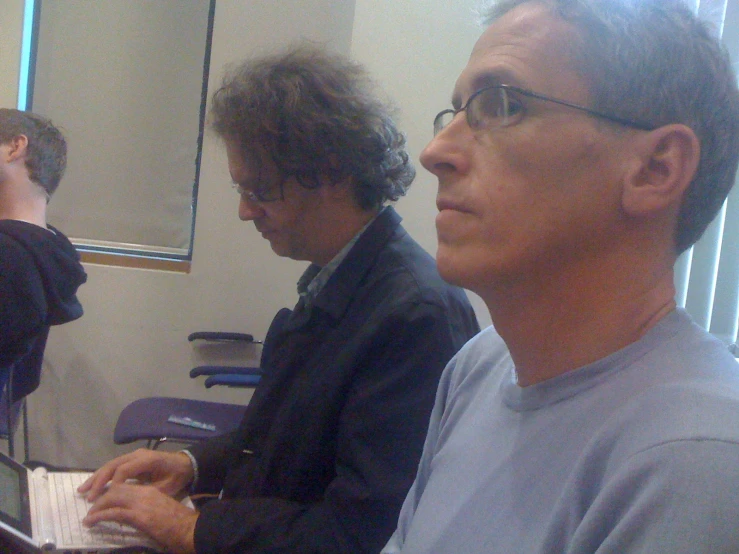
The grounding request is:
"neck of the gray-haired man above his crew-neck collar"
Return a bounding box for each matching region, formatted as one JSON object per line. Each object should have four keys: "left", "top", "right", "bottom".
{"left": 483, "top": 250, "right": 675, "bottom": 386}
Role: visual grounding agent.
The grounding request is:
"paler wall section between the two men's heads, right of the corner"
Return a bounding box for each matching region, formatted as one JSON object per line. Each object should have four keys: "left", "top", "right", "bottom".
{"left": 351, "top": 0, "right": 480, "bottom": 270}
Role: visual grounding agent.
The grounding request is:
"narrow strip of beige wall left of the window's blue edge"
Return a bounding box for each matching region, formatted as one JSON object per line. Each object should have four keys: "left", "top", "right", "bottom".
{"left": 0, "top": 0, "right": 23, "bottom": 108}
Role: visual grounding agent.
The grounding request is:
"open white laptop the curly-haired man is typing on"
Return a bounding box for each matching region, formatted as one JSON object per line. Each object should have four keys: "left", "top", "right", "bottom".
{"left": 0, "top": 453, "right": 160, "bottom": 554}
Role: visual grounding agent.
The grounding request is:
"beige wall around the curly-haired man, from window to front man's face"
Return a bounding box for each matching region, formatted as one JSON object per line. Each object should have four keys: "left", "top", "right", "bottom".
{"left": 13, "top": 0, "right": 487, "bottom": 466}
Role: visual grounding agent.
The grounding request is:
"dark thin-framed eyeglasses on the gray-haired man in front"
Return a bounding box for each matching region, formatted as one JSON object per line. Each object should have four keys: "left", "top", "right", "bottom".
{"left": 434, "top": 85, "right": 657, "bottom": 136}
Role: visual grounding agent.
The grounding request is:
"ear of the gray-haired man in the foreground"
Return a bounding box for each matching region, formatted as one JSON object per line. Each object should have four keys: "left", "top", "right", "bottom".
{"left": 622, "top": 123, "right": 700, "bottom": 217}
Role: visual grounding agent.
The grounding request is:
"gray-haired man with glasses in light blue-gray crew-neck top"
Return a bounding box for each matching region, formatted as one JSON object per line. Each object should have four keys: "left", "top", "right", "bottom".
{"left": 383, "top": 0, "right": 739, "bottom": 554}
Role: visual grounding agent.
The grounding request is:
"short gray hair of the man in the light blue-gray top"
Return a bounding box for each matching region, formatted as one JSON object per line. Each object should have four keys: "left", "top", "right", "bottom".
{"left": 482, "top": 0, "right": 739, "bottom": 253}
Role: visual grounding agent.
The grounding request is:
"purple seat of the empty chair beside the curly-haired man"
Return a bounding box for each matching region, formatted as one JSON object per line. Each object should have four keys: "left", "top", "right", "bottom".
{"left": 113, "top": 396, "right": 246, "bottom": 444}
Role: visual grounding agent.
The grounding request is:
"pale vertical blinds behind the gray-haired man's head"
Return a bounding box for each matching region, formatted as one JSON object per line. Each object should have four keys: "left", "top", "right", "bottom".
{"left": 675, "top": 0, "right": 739, "bottom": 355}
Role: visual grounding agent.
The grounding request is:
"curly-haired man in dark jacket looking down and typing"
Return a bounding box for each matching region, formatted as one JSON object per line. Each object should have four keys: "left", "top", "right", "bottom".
{"left": 81, "top": 48, "right": 479, "bottom": 554}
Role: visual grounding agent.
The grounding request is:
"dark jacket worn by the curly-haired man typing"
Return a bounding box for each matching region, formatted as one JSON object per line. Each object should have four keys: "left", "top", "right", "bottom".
{"left": 190, "top": 208, "right": 479, "bottom": 554}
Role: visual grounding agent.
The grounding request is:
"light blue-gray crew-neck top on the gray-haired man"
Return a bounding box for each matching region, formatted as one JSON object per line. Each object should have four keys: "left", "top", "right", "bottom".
{"left": 383, "top": 310, "right": 739, "bottom": 554}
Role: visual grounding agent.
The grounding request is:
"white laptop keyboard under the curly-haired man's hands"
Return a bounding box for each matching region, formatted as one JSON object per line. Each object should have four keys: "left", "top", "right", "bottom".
{"left": 48, "top": 472, "right": 150, "bottom": 546}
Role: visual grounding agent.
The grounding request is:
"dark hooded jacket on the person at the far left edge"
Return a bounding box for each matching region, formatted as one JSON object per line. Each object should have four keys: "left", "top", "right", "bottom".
{"left": 0, "top": 219, "right": 87, "bottom": 393}
